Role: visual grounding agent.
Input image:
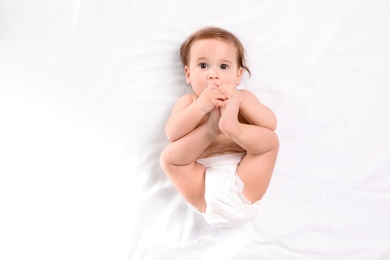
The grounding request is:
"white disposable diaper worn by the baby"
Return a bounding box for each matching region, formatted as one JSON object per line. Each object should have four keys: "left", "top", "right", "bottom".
{"left": 197, "top": 153, "right": 260, "bottom": 227}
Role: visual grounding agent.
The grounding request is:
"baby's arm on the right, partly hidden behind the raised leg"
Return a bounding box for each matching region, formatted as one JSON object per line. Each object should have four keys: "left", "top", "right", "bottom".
{"left": 240, "top": 89, "right": 277, "bottom": 131}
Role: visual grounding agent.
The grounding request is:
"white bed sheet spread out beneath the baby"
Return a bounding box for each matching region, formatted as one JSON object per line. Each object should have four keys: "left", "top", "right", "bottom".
{"left": 0, "top": 0, "right": 390, "bottom": 260}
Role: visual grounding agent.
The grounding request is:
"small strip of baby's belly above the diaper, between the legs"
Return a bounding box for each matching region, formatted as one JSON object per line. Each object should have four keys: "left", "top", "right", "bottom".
{"left": 199, "top": 134, "right": 245, "bottom": 158}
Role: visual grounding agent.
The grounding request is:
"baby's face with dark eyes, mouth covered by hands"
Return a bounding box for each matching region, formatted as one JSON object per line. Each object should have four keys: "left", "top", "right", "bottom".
{"left": 185, "top": 39, "right": 242, "bottom": 96}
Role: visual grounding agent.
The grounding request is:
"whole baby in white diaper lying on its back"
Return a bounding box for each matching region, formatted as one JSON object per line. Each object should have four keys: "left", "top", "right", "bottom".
{"left": 160, "top": 27, "right": 279, "bottom": 226}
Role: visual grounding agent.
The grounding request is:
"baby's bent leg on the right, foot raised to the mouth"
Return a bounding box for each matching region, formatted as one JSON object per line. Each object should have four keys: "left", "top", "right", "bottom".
{"left": 219, "top": 98, "right": 279, "bottom": 202}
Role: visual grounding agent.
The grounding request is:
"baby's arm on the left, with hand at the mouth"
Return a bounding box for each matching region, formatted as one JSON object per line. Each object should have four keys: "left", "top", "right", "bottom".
{"left": 165, "top": 85, "right": 225, "bottom": 142}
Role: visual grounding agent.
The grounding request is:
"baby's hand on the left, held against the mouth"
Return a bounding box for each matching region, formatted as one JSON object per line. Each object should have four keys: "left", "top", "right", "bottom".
{"left": 195, "top": 84, "right": 226, "bottom": 113}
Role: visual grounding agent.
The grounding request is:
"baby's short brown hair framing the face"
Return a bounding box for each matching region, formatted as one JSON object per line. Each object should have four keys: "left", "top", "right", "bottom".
{"left": 180, "top": 27, "right": 251, "bottom": 75}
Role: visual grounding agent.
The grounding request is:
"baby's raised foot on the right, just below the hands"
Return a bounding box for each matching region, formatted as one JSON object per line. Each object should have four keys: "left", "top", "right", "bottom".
{"left": 219, "top": 97, "right": 241, "bottom": 138}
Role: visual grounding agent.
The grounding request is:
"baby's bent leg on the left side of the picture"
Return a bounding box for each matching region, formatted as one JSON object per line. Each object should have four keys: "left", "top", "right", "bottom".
{"left": 160, "top": 108, "right": 220, "bottom": 212}
